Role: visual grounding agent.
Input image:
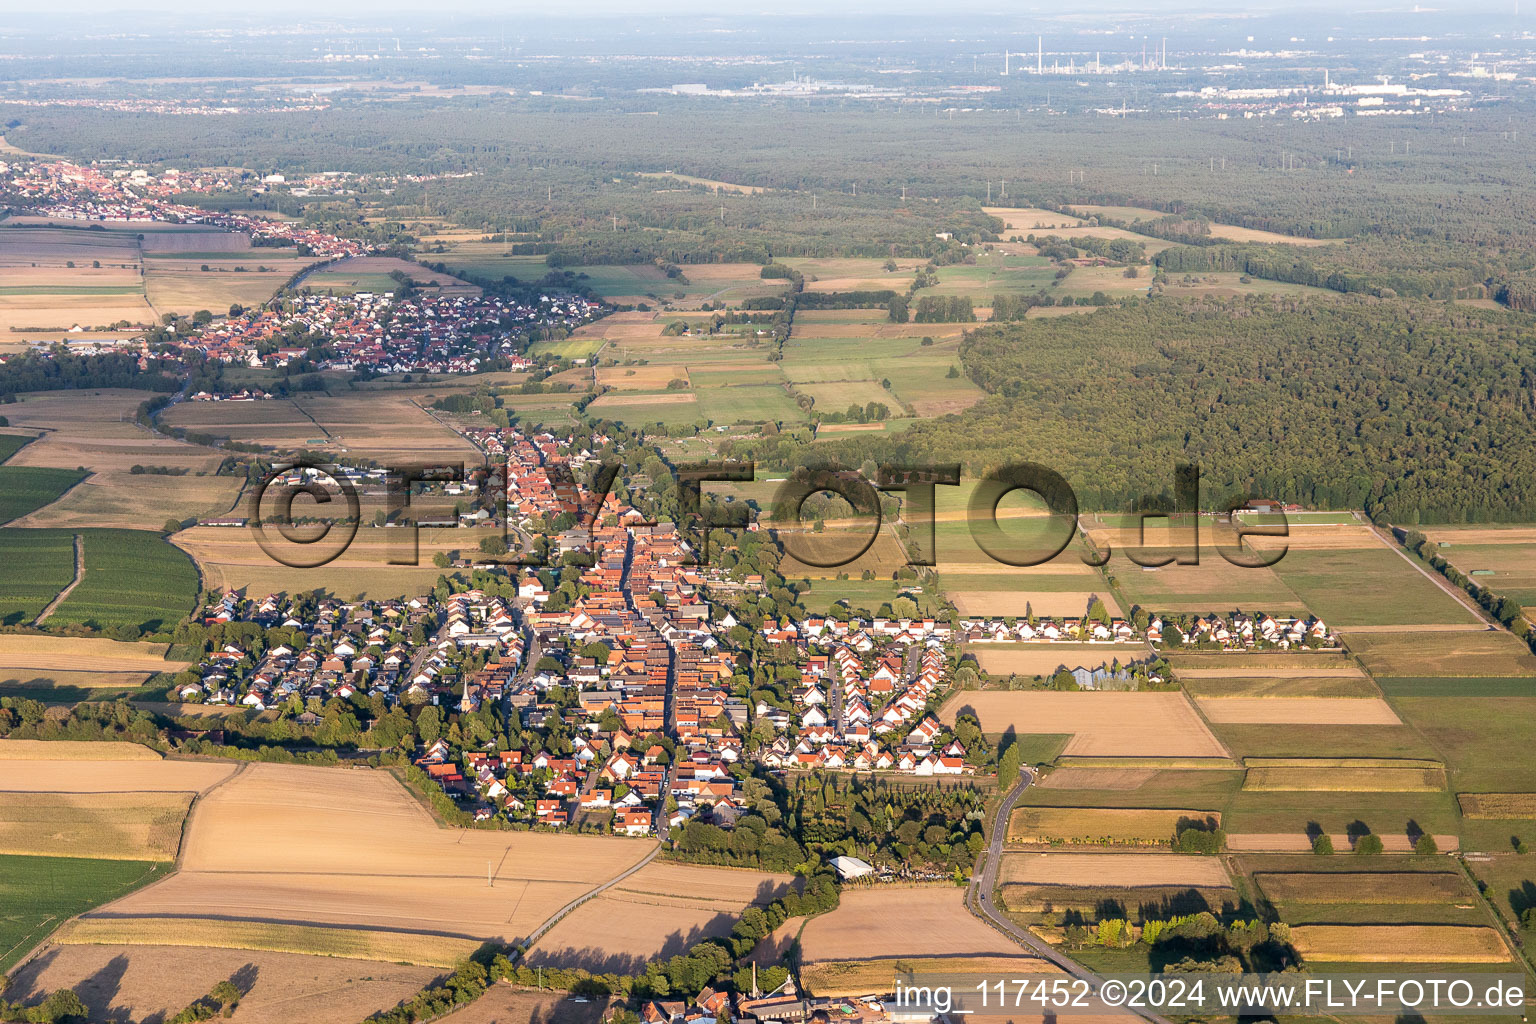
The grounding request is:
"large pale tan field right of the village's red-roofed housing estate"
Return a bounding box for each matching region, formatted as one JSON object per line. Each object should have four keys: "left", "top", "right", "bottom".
{"left": 940, "top": 689, "right": 1227, "bottom": 757}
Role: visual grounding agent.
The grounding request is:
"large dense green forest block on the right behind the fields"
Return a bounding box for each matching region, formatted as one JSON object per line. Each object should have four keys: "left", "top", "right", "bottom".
{"left": 817, "top": 296, "right": 1536, "bottom": 524}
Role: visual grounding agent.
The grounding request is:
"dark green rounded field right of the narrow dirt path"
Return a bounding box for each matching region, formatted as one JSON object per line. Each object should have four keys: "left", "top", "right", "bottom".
{"left": 48, "top": 530, "right": 198, "bottom": 631}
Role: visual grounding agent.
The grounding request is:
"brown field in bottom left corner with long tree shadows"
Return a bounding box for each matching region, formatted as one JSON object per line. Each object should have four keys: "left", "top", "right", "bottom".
{"left": 8, "top": 946, "right": 445, "bottom": 1024}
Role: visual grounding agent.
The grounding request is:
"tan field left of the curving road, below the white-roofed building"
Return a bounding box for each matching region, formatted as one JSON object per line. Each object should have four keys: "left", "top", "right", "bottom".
{"left": 800, "top": 886, "right": 1021, "bottom": 964}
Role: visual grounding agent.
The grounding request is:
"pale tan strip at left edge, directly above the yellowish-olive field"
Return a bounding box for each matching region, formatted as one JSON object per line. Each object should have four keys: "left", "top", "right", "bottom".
{"left": 0, "top": 758, "right": 235, "bottom": 794}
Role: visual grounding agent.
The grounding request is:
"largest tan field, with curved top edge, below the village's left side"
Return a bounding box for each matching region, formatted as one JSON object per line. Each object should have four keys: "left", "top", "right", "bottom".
{"left": 92, "top": 765, "right": 648, "bottom": 952}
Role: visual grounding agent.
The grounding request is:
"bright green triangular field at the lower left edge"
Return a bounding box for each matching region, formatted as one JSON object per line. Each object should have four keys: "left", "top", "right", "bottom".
{"left": 0, "top": 854, "right": 167, "bottom": 972}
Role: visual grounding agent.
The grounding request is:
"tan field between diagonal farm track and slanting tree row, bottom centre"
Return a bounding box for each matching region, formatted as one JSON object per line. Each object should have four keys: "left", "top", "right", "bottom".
{"left": 528, "top": 861, "right": 791, "bottom": 973}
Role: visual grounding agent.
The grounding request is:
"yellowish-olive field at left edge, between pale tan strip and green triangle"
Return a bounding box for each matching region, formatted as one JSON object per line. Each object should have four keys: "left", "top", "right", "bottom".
{"left": 0, "top": 781, "right": 192, "bottom": 860}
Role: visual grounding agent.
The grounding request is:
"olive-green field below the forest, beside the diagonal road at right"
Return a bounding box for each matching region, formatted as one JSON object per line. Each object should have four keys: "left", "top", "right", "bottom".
{"left": 1275, "top": 547, "right": 1476, "bottom": 626}
